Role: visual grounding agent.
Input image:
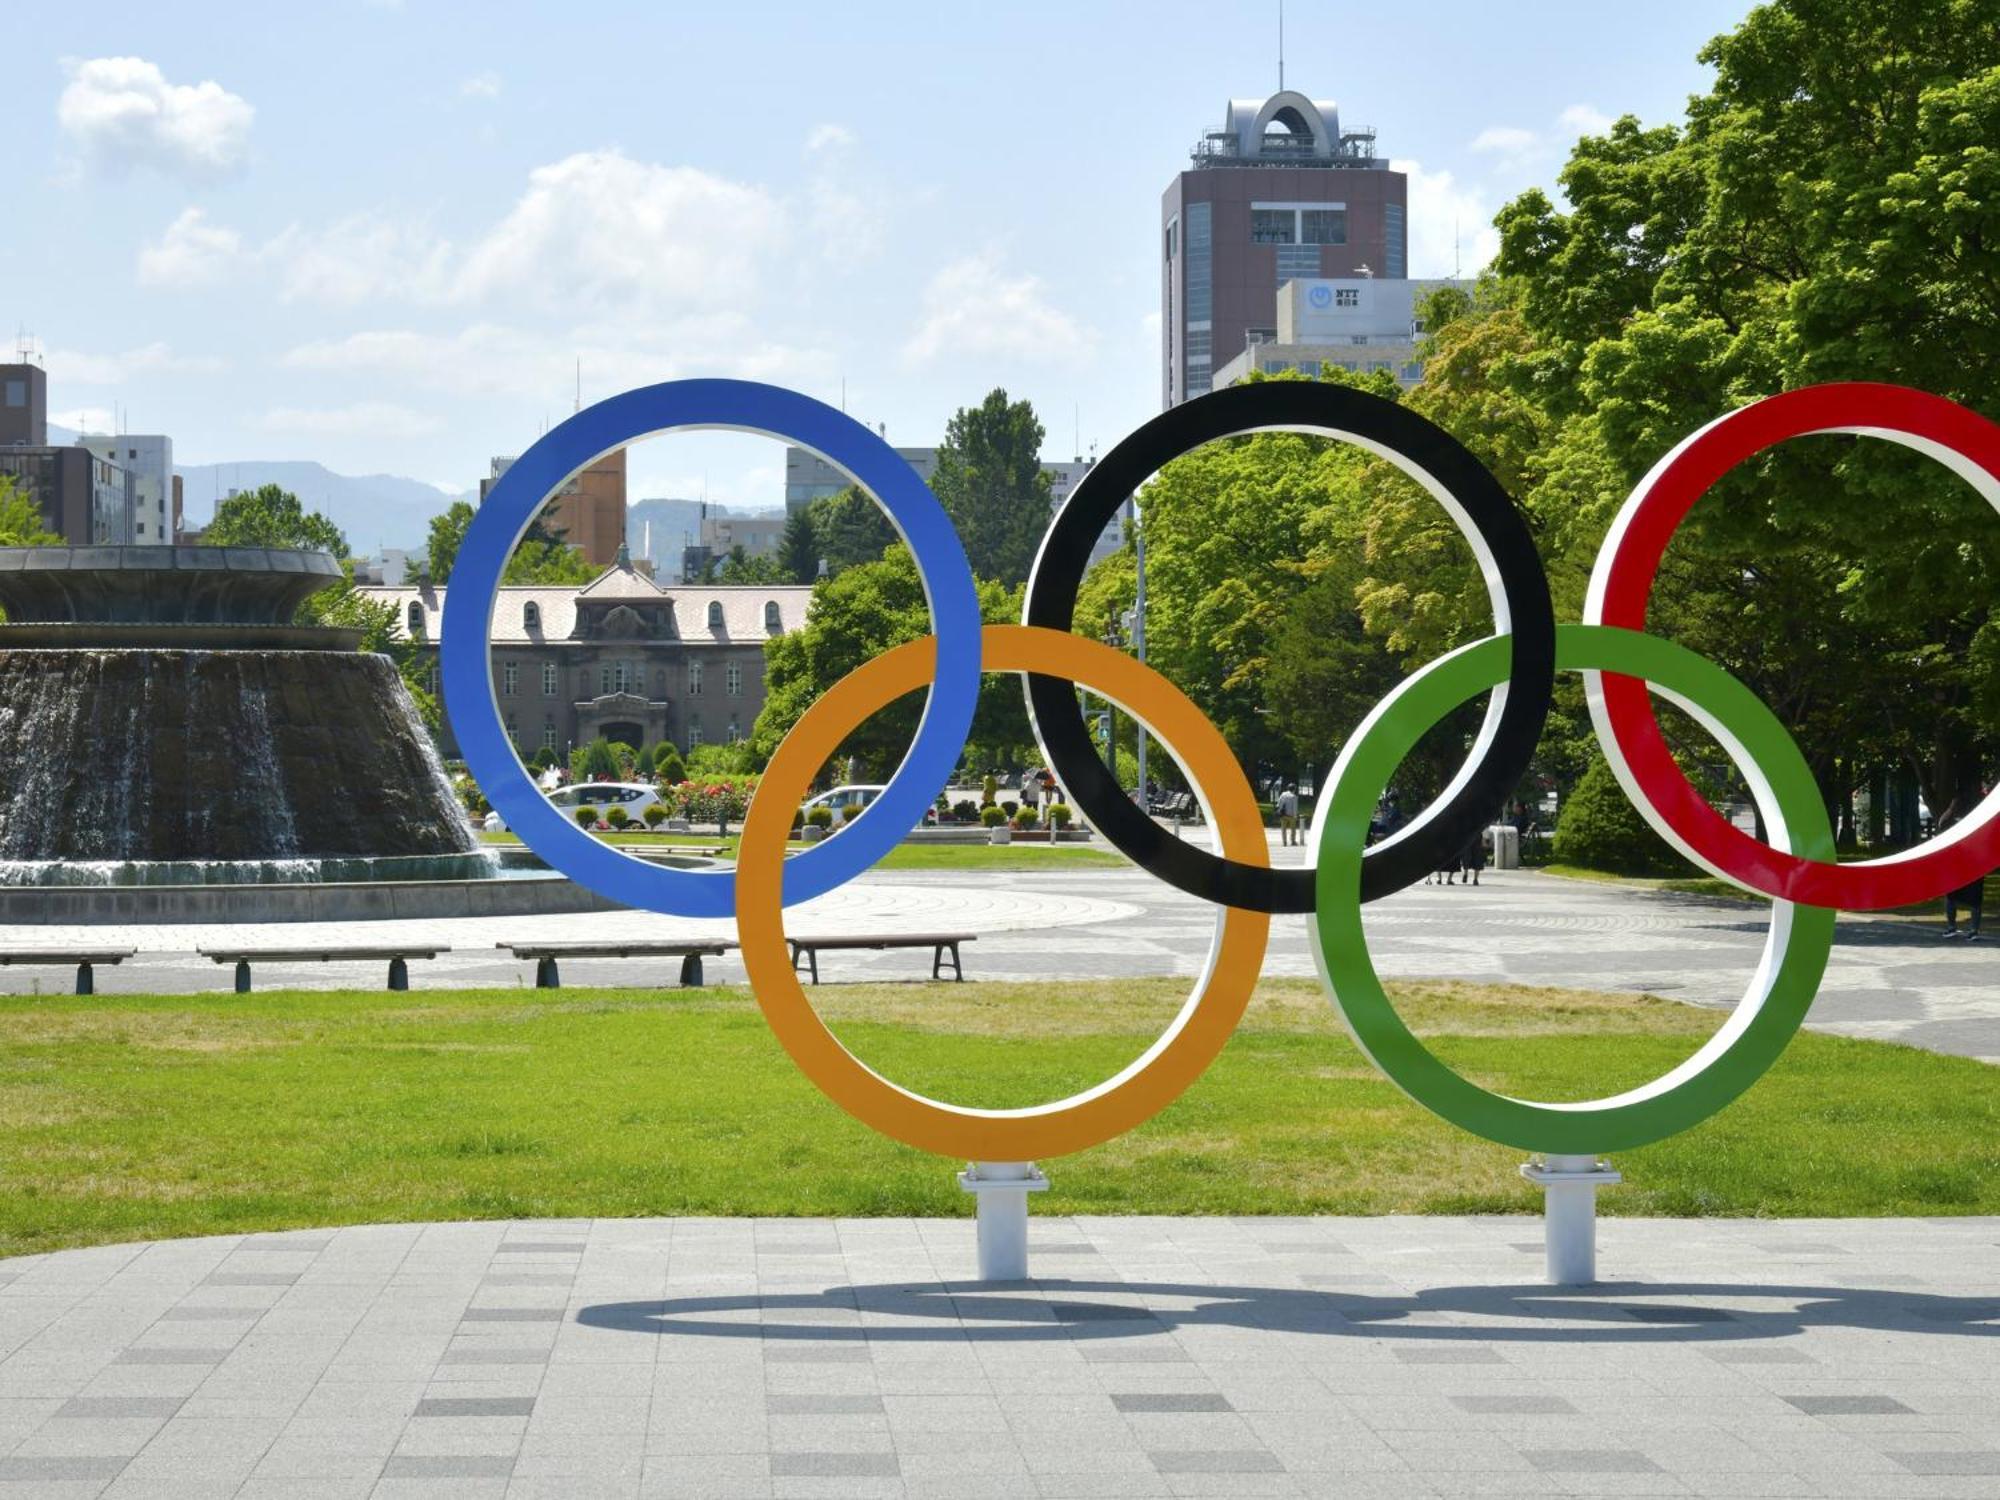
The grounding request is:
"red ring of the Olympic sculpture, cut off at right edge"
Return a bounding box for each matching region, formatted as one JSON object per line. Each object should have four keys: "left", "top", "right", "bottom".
{"left": 1584, "top": 382, "right": 2000, "bottom": 912}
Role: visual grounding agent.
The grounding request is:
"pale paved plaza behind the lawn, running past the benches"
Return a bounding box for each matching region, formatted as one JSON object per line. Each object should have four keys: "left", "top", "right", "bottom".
{"left": 0, "top": 848, "right": 2000, "bottom": 1062}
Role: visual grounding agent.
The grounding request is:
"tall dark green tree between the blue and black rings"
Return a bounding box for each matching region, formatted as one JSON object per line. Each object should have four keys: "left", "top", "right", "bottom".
{"left": 930, "top": 390, "right": 1052, "bottom": 588}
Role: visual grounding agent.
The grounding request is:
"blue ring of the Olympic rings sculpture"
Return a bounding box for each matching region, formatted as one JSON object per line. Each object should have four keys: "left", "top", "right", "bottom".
{"left": 438, "top": 380, "right": 980, "bottom": 916}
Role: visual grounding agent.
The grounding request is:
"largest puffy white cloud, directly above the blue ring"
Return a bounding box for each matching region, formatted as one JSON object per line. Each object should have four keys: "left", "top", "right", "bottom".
{"left": 456, "top": 150, "right": 784, "bottom": 310}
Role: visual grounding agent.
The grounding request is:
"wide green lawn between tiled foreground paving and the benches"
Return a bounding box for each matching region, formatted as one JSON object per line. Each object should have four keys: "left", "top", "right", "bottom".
{"left": 0, "top": 980, "right": 2000, "bottom": 1252}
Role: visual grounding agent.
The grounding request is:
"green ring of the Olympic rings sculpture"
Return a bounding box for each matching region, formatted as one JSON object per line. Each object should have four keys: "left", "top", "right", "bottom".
{"left": 1310, "top": 624, "right": 1834, "bottom": 1156}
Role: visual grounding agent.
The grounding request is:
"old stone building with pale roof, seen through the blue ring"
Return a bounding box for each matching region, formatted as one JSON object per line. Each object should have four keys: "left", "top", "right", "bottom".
{"left": 368, "top": 556, "right": 812, "bottom": 760}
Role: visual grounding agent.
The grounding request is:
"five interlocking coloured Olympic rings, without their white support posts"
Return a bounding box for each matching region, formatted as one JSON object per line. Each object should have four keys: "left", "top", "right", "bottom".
{"left": 440, "top": 380, "right": 2000, "bottom": 1160}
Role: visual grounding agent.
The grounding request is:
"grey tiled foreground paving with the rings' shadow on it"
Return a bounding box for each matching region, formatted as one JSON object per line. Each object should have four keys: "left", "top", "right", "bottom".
{"left": 0, "top": 1218, "right": 2000, "bottom": 1500}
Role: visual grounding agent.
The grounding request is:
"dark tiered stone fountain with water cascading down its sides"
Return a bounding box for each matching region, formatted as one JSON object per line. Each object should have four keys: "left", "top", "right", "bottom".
{"left": 0, "top": 548, "right": 494, "bottom": 884}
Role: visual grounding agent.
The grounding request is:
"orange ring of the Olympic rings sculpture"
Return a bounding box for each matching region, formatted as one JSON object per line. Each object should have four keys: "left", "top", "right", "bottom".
{"left": 736, "top": 626, "right": 1270, "bottom": 1162}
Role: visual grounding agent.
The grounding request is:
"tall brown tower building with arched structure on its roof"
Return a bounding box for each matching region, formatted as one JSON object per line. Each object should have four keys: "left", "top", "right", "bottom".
{"left": 1160, "top": 90, "right": 1410, "bottom": 406}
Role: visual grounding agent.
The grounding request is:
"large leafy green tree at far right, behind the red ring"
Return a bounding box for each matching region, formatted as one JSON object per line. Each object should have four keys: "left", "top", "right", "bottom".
{"left": 1496, "top": 0, "right": 2000, "bottom": 832}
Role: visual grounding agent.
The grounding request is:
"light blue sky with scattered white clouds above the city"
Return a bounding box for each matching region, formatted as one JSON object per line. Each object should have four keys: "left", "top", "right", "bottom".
{"left": 0, "top": 0, "right": 1748, "bottom": 516}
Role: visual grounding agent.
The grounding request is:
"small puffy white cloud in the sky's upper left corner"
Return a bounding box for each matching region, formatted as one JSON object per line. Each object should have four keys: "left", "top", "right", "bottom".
{"left": 56, "top": 58, "right": 256, "bottom": 182}
